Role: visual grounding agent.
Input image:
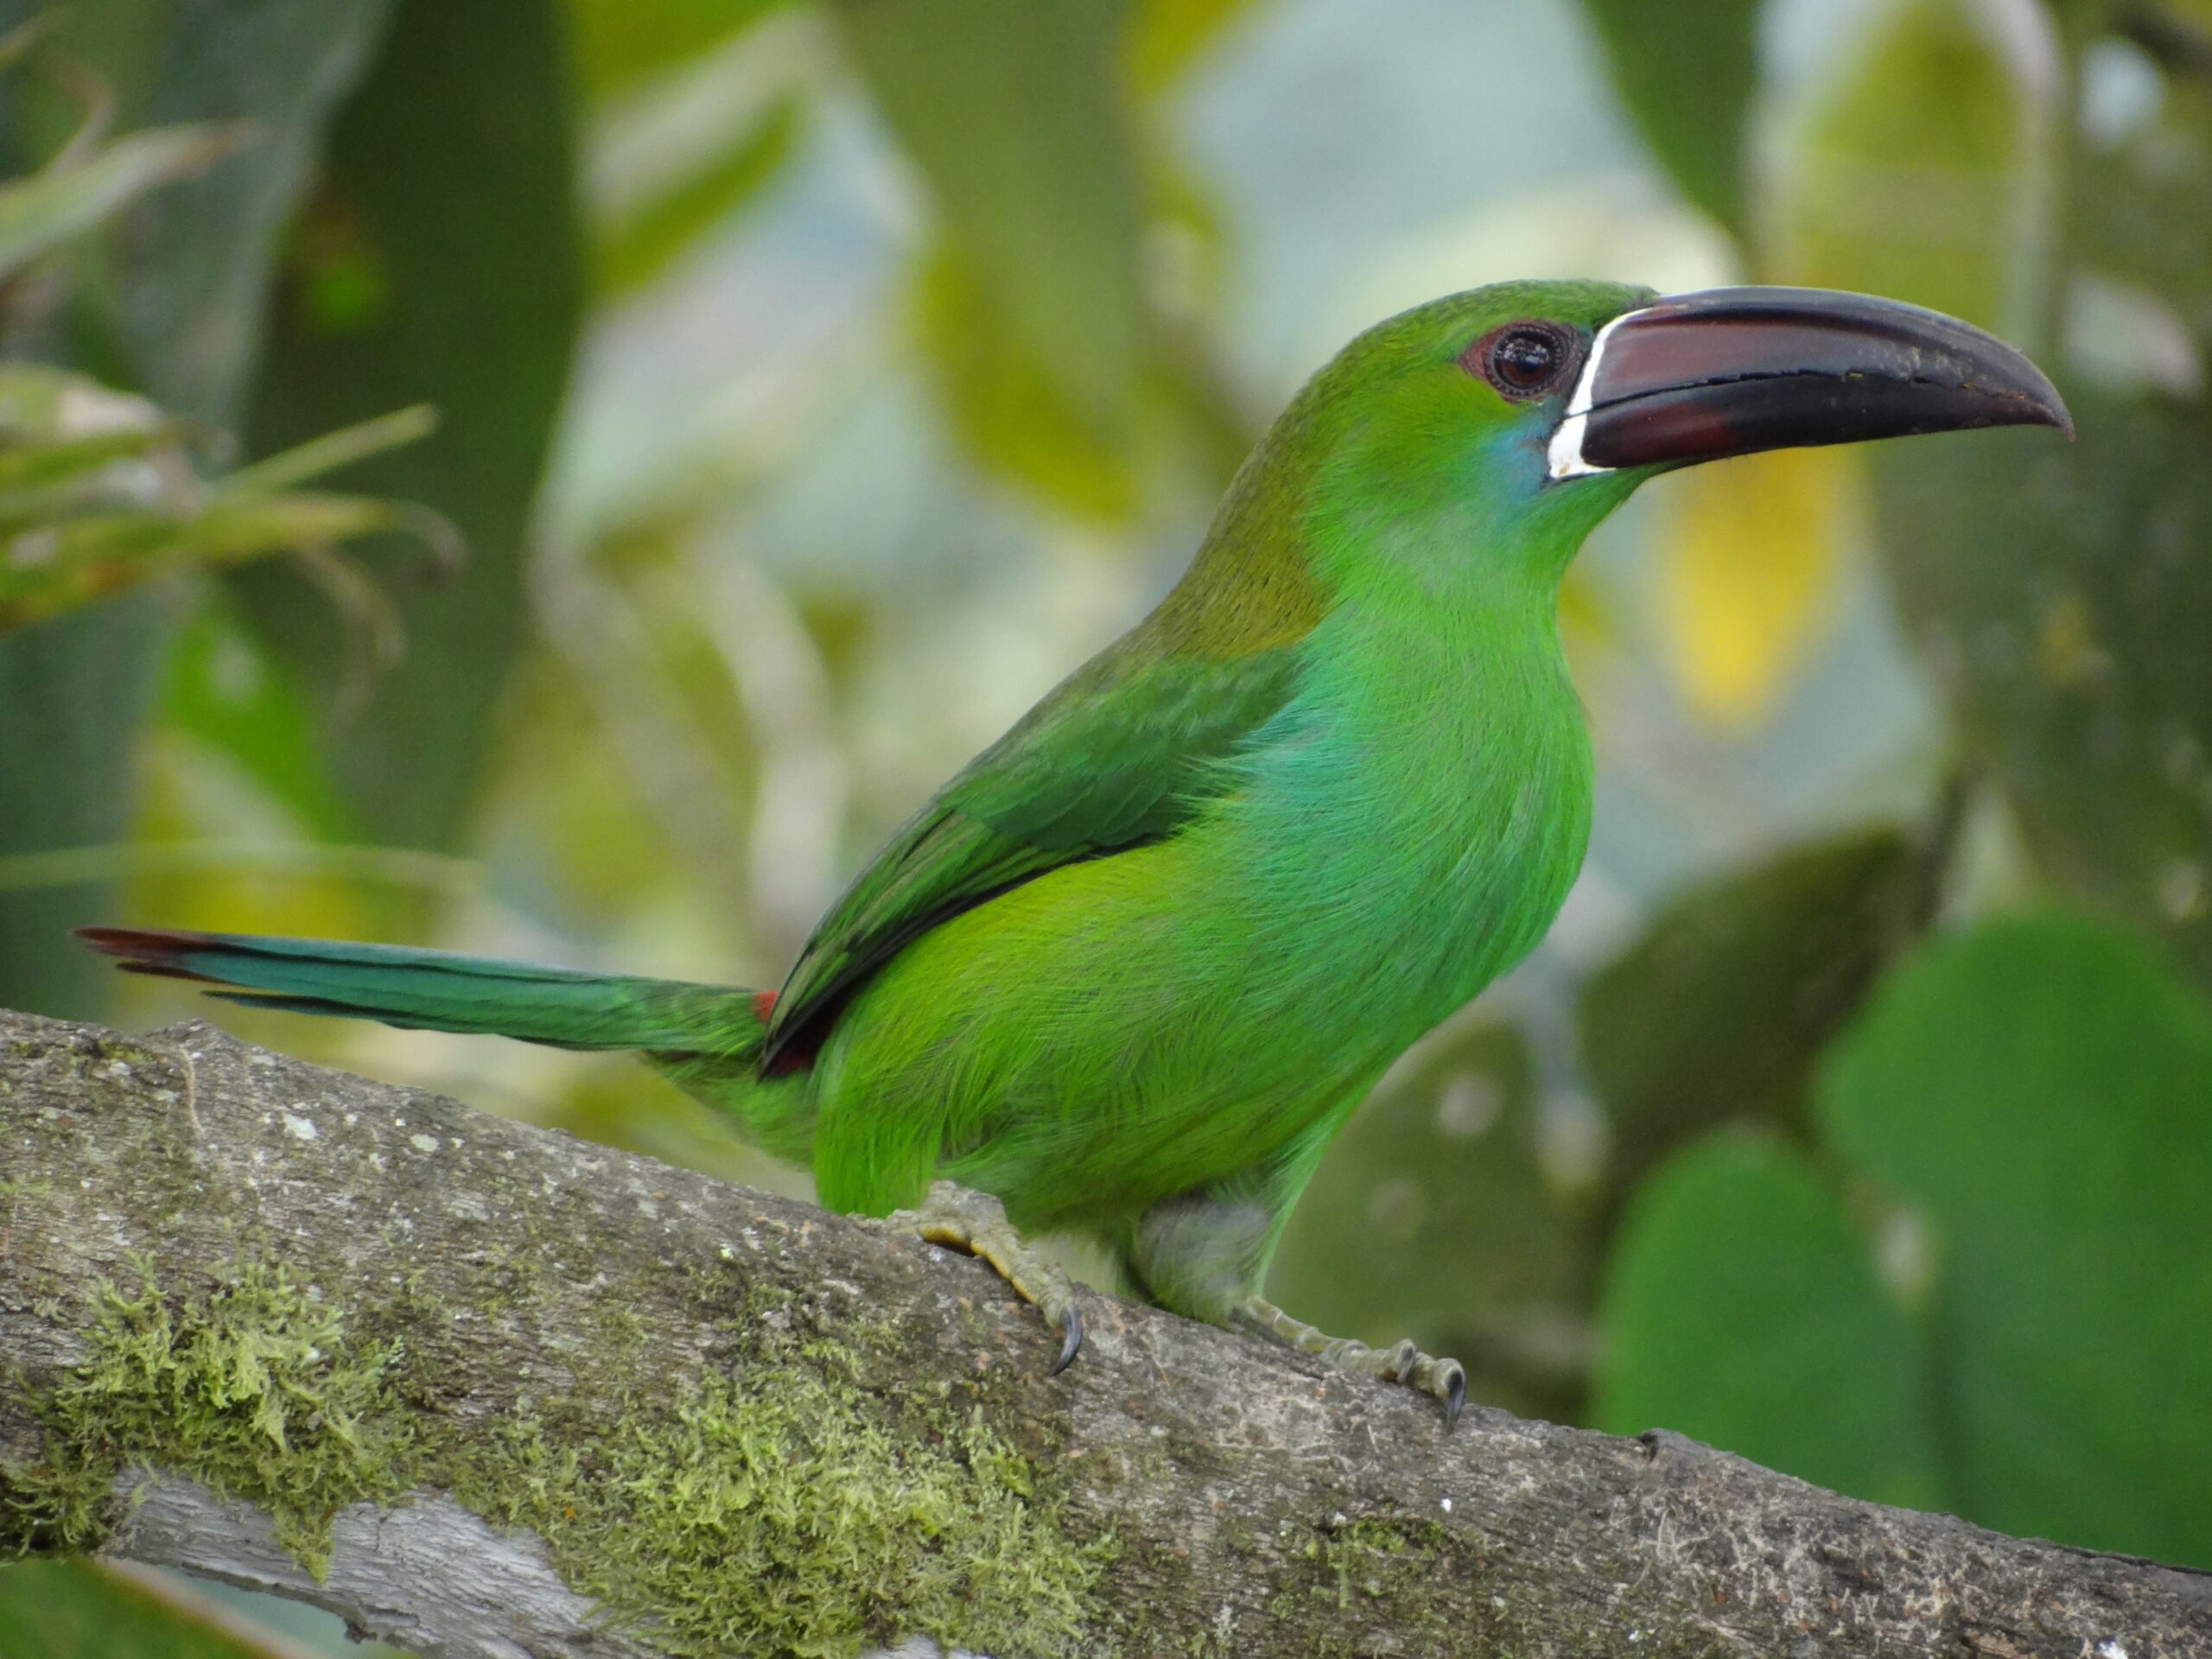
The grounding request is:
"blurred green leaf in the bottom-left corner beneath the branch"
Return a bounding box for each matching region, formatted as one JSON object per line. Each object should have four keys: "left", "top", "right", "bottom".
{"left": 0, "top": 1561, "right": 311, "bottom": 1659}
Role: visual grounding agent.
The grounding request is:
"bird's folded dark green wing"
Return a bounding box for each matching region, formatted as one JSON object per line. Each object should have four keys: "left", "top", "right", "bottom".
{"left": 763, "top": 646, "right": 1296, "bottom": 1064}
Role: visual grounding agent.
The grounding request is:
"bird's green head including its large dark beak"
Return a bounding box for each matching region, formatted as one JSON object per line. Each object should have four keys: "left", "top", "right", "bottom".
{"left": 1217, "top": 281, "right": 2066, "bottom": 606}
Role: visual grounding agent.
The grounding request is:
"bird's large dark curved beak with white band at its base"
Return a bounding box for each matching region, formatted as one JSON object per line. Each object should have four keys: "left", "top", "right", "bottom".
{"left": 1548, "top": 288, "right": 2073, "bottom": 478}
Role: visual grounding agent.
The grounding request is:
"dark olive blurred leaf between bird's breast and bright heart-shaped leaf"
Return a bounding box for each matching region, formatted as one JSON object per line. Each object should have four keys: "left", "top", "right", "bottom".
{"left": 1575, "top": 827, "right": 1924, "bottom": 1192}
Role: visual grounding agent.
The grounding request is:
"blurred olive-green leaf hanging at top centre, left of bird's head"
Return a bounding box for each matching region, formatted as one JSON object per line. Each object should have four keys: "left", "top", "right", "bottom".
{"left": 834, "top": 0, "right": 1144, "bottom": 493}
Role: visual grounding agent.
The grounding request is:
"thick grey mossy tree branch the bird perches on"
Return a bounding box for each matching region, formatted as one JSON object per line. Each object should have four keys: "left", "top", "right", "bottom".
{"left": 0, "top": 1015, "right": 2212, "bottom": 1659}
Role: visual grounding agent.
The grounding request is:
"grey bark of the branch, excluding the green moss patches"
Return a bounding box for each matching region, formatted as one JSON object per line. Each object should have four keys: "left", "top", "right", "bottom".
{"left": 0, "top": 1015, "right": 2212, "bottom": 1659}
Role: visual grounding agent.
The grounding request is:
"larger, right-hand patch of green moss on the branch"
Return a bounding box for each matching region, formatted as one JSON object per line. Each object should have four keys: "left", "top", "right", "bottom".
{"left": 460, "top": 1332, "right": 1103, "bottom": 1659}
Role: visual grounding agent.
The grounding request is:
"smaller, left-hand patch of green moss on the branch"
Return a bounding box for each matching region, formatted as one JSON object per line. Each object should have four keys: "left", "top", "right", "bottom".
{"left": 0, "top": 1265, "right": 418, "bottom": 1575}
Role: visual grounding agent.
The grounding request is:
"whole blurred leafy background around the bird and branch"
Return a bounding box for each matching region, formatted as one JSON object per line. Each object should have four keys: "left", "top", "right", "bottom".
{"left": 0, "top": 0, "right": 2212, "bottom": 1655}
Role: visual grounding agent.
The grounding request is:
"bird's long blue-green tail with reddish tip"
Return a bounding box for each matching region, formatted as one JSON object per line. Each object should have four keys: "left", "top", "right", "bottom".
{"left": 79, "top": 927, "right": 770, "bottom": 1059}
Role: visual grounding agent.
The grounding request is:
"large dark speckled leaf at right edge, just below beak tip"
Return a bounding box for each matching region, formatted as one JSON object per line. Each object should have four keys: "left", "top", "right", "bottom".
{"left": 1876, "top": 385, "right": 2212, "bottom": 978}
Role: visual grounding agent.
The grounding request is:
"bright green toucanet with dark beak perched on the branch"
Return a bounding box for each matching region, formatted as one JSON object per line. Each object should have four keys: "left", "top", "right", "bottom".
{"left": 79, "top": 281, "right": 2073, "bottom": 1425}
